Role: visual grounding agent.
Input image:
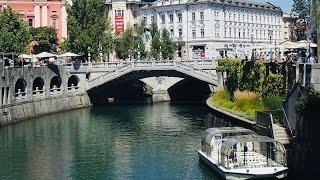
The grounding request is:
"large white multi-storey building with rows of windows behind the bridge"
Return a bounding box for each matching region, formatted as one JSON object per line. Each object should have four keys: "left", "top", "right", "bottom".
{"left": 138, "top": 0, "right": 284, "bottom": 59}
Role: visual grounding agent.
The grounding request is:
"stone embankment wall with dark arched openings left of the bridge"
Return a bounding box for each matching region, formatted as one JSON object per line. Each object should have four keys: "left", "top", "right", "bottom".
{"left": 0, "top": 62, "right": 91, "bottom": 126}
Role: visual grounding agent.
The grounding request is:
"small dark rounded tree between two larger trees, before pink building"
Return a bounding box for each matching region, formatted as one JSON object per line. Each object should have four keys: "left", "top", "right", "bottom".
{"left": 30, "top": 27, "right": 58, "bottom": 54}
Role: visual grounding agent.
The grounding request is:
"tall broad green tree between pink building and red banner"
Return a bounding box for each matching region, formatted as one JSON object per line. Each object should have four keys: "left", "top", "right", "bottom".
{"left": 65, "top": 0, "right": 114, "bottom": 59}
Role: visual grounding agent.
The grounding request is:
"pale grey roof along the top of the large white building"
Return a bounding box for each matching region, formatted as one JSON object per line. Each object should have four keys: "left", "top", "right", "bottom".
{"left": 142, "top": 0, "right": 282, "bottom": 12}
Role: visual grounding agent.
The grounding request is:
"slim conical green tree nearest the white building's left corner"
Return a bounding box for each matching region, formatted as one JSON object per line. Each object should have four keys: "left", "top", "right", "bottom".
{"left": 161, "top": 28, "right": 175, "bottom": 59}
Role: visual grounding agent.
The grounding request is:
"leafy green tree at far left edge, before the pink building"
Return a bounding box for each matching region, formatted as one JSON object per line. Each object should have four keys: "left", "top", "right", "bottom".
{"left": 0, "top": 7, "right": 31, "bottom": 53}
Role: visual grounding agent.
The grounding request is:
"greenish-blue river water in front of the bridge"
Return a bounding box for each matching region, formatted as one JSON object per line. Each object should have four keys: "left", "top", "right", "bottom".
{"left": 0, "top": 103, "right": 222, "bottom": 179}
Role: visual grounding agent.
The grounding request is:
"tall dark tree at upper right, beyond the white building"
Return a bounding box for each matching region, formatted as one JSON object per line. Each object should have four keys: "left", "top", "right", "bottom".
{"left": 292, "top": 0, "right": 310, "bottom": 40}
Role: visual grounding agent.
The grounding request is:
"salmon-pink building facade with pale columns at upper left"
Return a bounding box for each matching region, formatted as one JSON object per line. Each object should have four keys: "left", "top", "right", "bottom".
{"left": 0, "top": 0, "right": 67, "bottom": 41}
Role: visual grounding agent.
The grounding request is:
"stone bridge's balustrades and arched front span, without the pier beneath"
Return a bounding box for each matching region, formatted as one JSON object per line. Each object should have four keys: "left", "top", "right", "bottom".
{"left": 66, "top": 60, "right": 218, "bottom": 90}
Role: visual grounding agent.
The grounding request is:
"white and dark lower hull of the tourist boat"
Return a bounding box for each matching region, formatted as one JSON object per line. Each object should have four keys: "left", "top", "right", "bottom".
{"left": 198, "top": 151, "right": 287, "bottom": 179}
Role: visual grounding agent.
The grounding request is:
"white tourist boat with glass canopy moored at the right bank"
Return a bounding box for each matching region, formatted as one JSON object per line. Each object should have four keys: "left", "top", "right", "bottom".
{"left": 198, "top": 127, "right": 288, "bottom": 179}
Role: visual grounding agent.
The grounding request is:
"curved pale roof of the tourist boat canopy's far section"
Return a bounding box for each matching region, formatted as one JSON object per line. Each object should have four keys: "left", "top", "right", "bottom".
{"left": 202, "top": 127, "right": 255, "bottom": 145}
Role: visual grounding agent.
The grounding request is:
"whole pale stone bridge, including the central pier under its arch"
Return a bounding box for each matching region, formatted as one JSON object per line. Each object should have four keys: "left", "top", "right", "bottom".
{"left": 66, "top": 60, "right": 218, "bottom": 102}
